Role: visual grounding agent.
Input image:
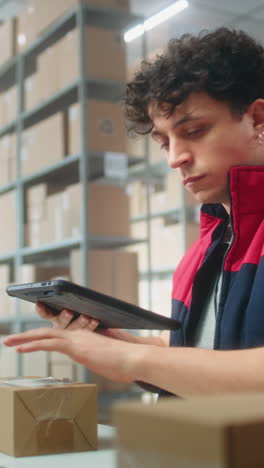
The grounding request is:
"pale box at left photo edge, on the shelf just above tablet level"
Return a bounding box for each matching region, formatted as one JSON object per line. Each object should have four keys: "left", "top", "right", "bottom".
{"left": 0, "top": 190, "right": 17, "bottom": 255}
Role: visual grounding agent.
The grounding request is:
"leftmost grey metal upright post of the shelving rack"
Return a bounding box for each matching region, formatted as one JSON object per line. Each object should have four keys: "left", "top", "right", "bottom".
{"left": 12, "top": 54, "right": 25, "bottom": 375}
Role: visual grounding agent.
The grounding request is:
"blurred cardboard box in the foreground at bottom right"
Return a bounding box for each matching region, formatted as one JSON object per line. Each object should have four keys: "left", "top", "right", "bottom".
{"left": 113, "top": 393, "right": 264, "bottom": 468}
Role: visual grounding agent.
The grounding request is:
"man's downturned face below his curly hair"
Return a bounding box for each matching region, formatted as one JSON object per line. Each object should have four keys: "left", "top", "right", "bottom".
{"left": 149, "top": 93, "right": 264, "bottom": 207}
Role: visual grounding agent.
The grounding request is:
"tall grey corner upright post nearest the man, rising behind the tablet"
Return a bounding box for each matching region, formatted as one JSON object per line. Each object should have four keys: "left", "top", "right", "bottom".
{"left": 76, "top": 4, "right": 91, "bottom": 382}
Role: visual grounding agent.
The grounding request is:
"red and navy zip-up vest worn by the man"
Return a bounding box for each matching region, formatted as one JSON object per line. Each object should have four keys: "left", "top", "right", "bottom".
{"left": 161, "top": 166, "right": 264, "bottom": 395}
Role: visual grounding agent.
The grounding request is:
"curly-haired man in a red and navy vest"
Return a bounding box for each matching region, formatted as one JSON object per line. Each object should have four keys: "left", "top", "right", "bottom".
{"left": 5, "top": 28, "right": 264, "bottom": 396}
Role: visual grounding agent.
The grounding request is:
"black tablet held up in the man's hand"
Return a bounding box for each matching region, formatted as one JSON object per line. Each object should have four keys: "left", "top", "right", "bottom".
{"left": 6, "top": 280, "right": 180, "bottom": 330}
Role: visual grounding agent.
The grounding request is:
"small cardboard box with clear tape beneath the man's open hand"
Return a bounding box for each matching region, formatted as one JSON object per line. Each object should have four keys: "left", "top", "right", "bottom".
{"left": 0, "top": 379, "right": 97, "bottom": 457}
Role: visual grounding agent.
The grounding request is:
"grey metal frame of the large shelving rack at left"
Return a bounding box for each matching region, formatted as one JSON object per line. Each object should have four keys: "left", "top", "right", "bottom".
{"left": 0, "top": 4, "right": 146, "bottom": 375}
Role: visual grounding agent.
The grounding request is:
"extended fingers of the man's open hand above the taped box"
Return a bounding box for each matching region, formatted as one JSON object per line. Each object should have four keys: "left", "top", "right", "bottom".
{"left": 3, "top": 328, "right": 67, "bottom": 346}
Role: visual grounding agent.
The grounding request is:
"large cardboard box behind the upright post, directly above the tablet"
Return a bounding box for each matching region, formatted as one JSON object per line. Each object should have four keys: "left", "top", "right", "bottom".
{"left": 70, "top": 249, "right": 138, "bottom": 305}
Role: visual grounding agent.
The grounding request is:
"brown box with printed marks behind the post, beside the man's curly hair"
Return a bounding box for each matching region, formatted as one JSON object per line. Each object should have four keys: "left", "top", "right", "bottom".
{"left": 67, "top": 99, "right": 127, "bottom": 154}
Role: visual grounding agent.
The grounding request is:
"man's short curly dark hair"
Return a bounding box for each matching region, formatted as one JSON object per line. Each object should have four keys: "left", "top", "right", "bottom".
{"left": 125, "top": 27, "right": 264, "bottom": 135}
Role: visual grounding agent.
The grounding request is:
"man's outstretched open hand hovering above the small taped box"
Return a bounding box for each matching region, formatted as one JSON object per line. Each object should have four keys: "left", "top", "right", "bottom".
{"left": 4, "top": 328, "right": 145, "bottom": 382}
